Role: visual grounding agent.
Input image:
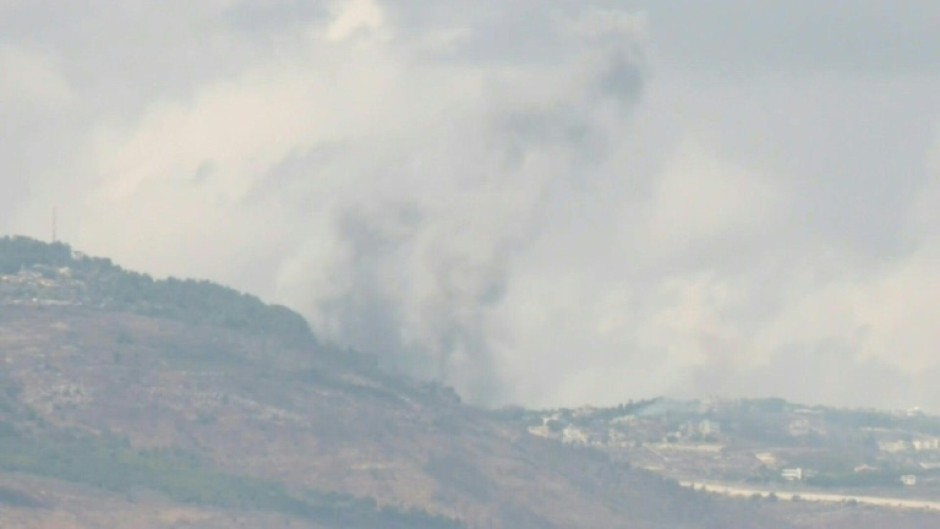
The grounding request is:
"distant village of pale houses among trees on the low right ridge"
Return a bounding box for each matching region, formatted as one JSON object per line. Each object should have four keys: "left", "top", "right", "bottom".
{"left": 510, "top": 399, "right": 940, "bottom": 498}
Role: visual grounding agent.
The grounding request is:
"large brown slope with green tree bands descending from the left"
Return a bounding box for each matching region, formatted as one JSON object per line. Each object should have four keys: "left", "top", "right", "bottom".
{"left": 0, "top": 238, "right": 936, "bottom": 529}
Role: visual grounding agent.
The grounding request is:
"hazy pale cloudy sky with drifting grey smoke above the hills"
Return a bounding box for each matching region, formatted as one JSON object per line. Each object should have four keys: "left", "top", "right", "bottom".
{"left": 0, "top": 0, "right": 940, "bottom": 412}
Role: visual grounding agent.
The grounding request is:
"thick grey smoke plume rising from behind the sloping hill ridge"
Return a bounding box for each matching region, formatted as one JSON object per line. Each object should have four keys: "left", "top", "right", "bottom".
{"left": 272, "top": 3, "right": 642, "bottom": 401}
